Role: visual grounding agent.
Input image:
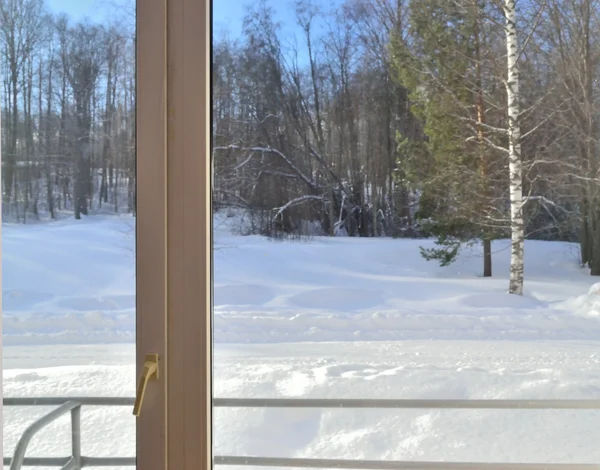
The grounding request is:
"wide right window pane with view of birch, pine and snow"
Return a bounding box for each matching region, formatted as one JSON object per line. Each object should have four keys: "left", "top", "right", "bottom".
{"left": 212, "top": 0, "right": 600, "bottom": 469}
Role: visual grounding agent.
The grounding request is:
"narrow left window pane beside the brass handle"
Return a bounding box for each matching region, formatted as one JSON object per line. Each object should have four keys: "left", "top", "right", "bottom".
{"left": 0, "top": 0, "right": 136, "bottom": 469}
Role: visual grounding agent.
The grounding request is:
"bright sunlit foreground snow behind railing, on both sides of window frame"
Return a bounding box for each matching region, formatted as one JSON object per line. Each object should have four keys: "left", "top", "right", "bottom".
{"left": 4, "top": 341, "right": 600, "bottom": 470}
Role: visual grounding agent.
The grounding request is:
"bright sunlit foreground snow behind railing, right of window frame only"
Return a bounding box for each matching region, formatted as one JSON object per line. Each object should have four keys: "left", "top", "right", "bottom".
{"left": 214, "top": 341, "right": 600, "bottom": 463}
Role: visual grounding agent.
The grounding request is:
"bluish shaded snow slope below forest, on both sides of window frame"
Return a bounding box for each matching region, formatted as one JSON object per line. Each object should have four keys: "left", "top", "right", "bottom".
{"left": 2, "top": 217, "right": 600, "bottom": 345}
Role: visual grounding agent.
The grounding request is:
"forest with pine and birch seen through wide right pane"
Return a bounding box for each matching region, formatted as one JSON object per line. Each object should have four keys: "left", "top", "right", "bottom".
{"left": 213, "top": 0, "right": 600, "bottom": 292}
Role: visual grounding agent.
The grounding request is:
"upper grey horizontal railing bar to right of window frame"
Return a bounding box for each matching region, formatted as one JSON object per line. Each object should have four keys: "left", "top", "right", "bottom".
{"left": 213, "top": 398, "right": 600, "bottom": 410}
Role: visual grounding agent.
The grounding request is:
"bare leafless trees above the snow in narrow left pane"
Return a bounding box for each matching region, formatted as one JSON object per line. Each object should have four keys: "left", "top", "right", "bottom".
{"left": 0, "top": 0, "right": 135, "bottom": 223}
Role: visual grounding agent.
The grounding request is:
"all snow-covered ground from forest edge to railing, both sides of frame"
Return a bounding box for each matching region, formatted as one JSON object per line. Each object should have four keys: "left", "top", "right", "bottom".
{"left": 3, "top": 217, "right": 600, "bottom": 463}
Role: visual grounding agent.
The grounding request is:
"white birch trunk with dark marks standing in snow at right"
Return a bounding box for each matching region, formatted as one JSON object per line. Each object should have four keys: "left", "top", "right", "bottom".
{"left": 504, "top": 0, "right": 525, "bottom": 295}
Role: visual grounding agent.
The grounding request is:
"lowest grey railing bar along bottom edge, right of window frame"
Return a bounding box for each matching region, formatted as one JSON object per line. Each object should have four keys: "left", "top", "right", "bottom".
{"left": 213, "top": 456, "right": 600, "bottom": 470}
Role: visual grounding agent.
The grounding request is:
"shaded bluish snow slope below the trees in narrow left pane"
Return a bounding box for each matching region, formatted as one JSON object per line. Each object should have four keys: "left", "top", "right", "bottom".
{"left": 2, "top": 216, "right": 135, "bottom": 345}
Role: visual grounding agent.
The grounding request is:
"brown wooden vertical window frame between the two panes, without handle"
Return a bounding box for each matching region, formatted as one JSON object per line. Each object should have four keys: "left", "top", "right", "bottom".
{"left": 136, "top": 0, "right": 212, "bottom": 470}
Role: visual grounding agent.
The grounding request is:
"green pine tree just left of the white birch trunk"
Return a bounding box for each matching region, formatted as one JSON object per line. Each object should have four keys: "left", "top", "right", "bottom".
{"left": 392, "top": 0, "right": 508, "bottom": 276}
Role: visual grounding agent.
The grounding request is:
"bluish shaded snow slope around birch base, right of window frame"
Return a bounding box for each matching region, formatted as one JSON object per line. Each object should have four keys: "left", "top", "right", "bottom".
{"left": 214, "top": 213, "right": 600, "bottom": 343}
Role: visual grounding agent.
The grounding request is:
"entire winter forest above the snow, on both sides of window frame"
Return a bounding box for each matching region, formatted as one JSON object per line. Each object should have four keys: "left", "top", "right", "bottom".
{"left": 0, "top": 0, "right": 600, "bottom": 294}
